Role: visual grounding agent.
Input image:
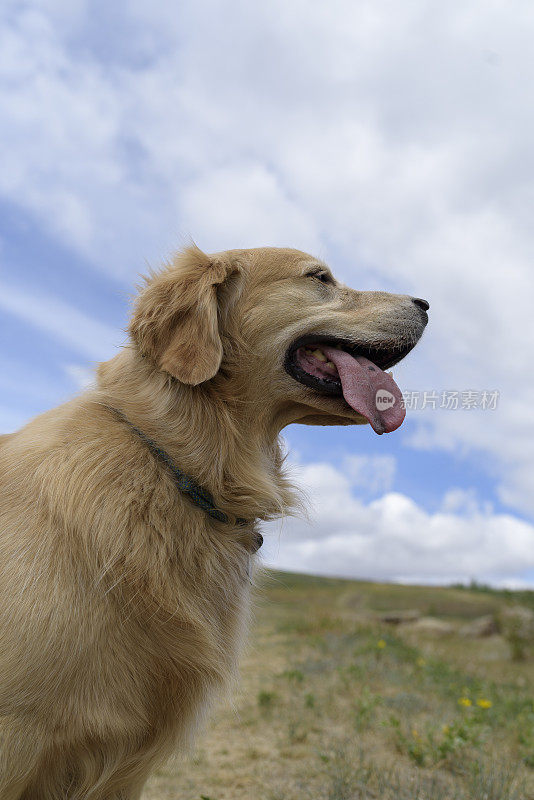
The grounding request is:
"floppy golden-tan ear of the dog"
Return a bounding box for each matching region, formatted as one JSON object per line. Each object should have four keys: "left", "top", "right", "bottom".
{"left": 128, "top": 245, "right": 243, "bottom": 385}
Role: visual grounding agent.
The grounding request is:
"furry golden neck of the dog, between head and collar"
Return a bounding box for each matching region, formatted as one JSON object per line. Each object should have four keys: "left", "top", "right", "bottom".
{"left": 97, "top": 347, "right": 298, "bottom": 519}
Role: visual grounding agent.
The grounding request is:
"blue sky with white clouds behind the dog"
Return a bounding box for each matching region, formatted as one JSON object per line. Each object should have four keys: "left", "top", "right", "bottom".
{"left": 0, "top": 0, "right": 534, "bottom": 586}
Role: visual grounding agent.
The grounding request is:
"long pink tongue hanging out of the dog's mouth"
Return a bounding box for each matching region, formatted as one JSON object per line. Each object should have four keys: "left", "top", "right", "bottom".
{"left": 321, "top": 346, "right": 406, "bottom": 433}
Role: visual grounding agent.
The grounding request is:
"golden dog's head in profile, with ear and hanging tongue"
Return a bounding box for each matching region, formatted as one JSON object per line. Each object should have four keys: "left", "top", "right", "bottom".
{"left": 129, "top": 247, "right": 428, "bottom": 433}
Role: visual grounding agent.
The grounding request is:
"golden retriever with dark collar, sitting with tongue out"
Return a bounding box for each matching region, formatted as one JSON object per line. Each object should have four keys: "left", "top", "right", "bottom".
{"left": 0, "top": 246, "right": 428, "bottom": 800}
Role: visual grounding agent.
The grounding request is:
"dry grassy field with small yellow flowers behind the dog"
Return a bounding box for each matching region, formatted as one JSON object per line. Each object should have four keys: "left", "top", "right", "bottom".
{"left": 143, "top": 572, "right": 534, "bottom": 800}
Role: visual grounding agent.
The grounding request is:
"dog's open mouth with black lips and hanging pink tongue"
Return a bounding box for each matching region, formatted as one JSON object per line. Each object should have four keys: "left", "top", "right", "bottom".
{"left": 284, "top": 334, "right": 415, "bottom": 433}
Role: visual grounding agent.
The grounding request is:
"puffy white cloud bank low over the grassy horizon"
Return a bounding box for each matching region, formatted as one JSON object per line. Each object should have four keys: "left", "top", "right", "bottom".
{"left": 264, "top": 463, "right": 534, "bottom": 586}
